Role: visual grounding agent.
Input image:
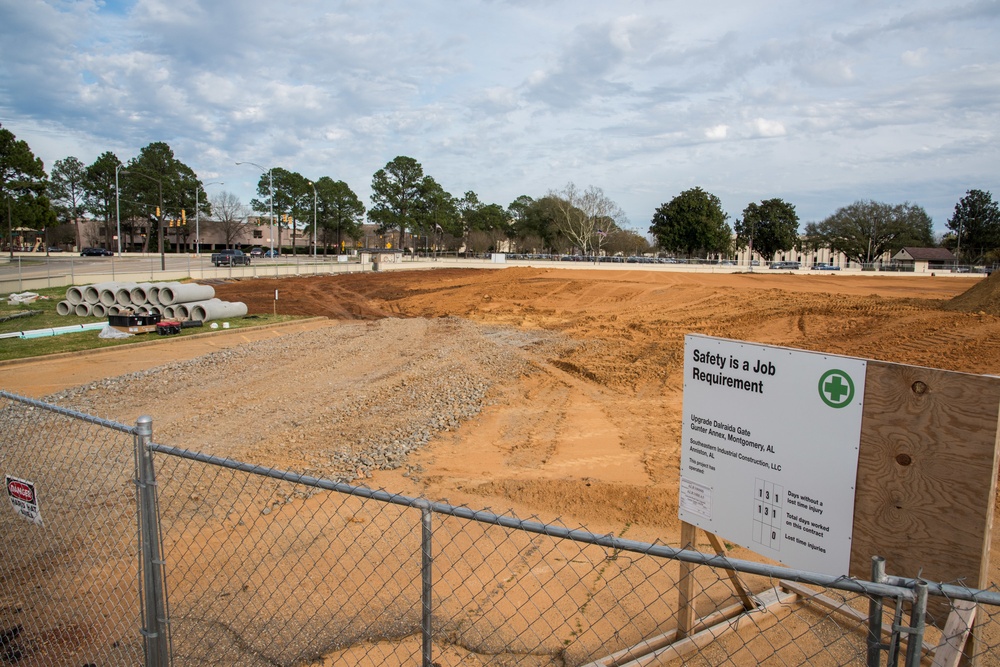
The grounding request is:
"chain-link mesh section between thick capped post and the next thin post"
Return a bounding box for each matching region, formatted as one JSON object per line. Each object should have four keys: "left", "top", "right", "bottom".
{"left": 157, "top": 456, "right": 421, "bottom": 665}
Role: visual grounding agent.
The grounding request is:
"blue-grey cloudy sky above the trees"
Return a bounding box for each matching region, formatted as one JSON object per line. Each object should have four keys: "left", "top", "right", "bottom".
{"left": 0, "top": 0, "right": 1000, "bottom": 233}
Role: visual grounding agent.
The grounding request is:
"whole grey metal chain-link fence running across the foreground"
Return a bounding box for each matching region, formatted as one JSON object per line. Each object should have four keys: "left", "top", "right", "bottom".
{"left": 0, "top": 392, "right": 1000, "bottom": 667}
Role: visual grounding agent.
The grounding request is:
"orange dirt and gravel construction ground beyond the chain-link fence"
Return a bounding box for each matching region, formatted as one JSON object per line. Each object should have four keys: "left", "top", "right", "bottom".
{"left": 0, "top": 268, "right": 1000, "bottom": 664}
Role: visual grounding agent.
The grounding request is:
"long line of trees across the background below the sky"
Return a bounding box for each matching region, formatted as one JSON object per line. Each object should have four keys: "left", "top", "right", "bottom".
{"left": 0, "top": 126, "right": 1000, "bottom": 264}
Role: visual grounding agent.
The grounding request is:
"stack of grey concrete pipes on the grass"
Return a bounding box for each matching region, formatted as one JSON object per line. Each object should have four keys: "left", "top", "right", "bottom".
{"left": 56, "top": 282, "right": 247, "bottom": 322}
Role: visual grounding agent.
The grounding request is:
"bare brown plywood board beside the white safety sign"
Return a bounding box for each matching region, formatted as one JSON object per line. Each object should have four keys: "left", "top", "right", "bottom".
{"left": 851, "top": 361, "right": 1000, "bottom": 588}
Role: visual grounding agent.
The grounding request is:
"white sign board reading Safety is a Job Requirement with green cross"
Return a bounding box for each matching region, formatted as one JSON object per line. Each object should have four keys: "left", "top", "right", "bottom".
{"left": 679, "top": 335, "right": 867, "bottom": 575}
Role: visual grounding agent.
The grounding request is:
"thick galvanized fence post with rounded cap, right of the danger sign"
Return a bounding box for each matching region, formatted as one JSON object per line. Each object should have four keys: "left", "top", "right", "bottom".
{"left": 135, "top": 415, "right": 170, "bottom": 667}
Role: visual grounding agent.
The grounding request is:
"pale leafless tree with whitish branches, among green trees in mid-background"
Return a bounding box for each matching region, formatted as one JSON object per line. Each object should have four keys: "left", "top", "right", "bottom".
{"left": 549, "top": 183, "right": 627, "bottom": 255}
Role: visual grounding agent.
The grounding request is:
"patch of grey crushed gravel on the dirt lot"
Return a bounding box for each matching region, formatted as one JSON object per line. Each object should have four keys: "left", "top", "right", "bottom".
{"left": 47, "top": 317, "right": 565, "bottom": 481}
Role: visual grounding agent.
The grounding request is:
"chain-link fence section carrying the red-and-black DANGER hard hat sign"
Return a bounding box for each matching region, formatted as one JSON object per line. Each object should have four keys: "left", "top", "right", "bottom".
{"left": 0, "top": 398, "right": 143, "bottom": 665}
